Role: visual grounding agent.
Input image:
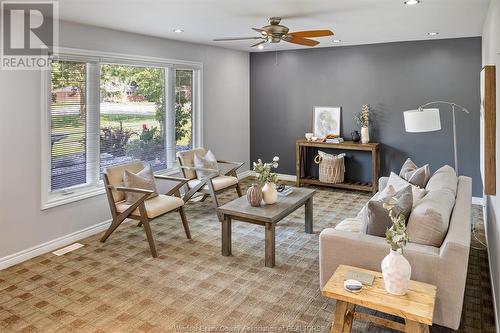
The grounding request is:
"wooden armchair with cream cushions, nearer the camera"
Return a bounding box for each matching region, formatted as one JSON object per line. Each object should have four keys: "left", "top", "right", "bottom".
{"left": 101, "top": 161, "right": 191, "bottom": 258}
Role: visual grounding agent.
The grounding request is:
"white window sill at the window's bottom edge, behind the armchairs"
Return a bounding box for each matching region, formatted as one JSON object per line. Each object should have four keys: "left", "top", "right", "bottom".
{"left": 41, "top": 167, "right": 179, "bottom": 210}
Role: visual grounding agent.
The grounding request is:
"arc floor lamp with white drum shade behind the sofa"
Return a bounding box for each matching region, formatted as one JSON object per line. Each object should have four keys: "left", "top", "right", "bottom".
{"left": 403, "top": 101, "right": 470, "bottom": 174}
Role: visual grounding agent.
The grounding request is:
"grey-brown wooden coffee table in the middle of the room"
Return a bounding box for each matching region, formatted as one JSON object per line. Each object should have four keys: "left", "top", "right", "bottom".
{"left": 217, "top": 187, "right": 315, "bottom": 267}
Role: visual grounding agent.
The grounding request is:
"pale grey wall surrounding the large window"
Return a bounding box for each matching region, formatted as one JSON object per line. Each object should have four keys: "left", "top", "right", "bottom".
{"left": 0, "top": 22, "right": 250, "bottom": 267}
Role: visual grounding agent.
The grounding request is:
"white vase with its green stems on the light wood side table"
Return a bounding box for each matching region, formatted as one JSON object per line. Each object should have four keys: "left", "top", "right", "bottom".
{"left": 381, "top": 198, "right": 411, "bottom": 295}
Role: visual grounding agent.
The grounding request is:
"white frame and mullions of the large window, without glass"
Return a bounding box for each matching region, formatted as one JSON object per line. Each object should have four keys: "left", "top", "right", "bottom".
{"left": 41, "top": 47, "right": 203, "bottom": 210}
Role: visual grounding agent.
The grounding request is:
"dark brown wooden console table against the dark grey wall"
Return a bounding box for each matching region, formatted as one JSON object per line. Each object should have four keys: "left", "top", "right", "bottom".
{"left": 295, "top": 139, "right": 380, "bottom": 193}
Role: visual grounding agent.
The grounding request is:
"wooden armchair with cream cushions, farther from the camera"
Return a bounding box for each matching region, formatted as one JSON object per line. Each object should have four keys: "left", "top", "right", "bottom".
{"left": 177, "top": 148, "right": 243, "bottom": 213}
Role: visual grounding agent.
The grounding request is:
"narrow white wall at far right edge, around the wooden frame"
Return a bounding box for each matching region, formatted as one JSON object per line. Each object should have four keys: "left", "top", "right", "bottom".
{"left": 482, "top": 0, "right": 500, "bottom": 331}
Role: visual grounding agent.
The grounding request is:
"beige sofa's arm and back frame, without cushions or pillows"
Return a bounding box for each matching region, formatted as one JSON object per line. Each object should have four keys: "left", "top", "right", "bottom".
{"left": 319, "top": 172, "right": 472, "bottom": 329}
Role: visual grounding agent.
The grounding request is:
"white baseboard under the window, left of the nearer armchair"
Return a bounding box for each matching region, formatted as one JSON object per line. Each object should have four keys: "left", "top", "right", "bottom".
{"left": 0, "top": 219, "right": 111, "bottom": 270}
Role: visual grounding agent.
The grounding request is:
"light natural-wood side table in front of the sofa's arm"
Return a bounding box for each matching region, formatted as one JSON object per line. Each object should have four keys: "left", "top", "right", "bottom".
{"left": 321, "top": 265, "right": 436, "bottom": 333}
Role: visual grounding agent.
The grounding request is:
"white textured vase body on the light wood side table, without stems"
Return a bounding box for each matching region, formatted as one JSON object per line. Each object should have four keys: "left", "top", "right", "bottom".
{"left": 381, "top": 250, "right": 411, "bottom": 295}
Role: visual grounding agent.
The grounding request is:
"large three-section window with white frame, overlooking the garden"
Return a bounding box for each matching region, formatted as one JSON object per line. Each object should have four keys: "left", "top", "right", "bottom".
{"left": 42, "top": 51, "right": 201, "bottom": 207}
